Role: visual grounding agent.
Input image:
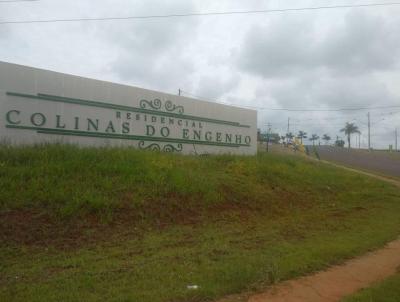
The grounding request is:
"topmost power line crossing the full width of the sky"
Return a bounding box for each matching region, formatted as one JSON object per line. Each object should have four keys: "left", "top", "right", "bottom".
{"left": 0, "top": 0, "right": 400, "bottom": 25}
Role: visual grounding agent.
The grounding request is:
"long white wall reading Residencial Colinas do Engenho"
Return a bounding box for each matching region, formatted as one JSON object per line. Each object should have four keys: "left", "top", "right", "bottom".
{"left": 0, "top": 62, "right": 257, "bottom": 155}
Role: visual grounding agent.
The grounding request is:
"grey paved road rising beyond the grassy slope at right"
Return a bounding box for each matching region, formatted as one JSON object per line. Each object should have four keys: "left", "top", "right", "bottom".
{"left": 318, "top": 146, "right": 400, "bottom": 178}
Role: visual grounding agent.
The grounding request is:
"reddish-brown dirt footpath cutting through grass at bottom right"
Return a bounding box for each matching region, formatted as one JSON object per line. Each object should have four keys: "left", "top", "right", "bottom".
{"left": 248, "top": 240, "right": 400, "bottom": 302}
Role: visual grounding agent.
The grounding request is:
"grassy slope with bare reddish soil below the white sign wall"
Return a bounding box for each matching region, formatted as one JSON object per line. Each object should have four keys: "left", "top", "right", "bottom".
{"left": 0, "top": 145, "right": 400, "bottom": 302}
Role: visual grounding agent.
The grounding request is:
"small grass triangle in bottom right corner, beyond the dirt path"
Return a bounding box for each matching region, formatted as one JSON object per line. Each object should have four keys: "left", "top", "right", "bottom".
{"left": 343, "top": 273, "right": 400, "bottom": 302}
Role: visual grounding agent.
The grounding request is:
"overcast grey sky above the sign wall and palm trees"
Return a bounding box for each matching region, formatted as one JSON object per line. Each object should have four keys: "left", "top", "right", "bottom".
{"left": 0, "top": 0, "right": 400, "bottom": 148}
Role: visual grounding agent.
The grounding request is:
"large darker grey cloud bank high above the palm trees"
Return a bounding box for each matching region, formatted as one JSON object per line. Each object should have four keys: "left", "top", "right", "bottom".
{"left": 238, "top": 11, "right": 400, "bottom": 78}
